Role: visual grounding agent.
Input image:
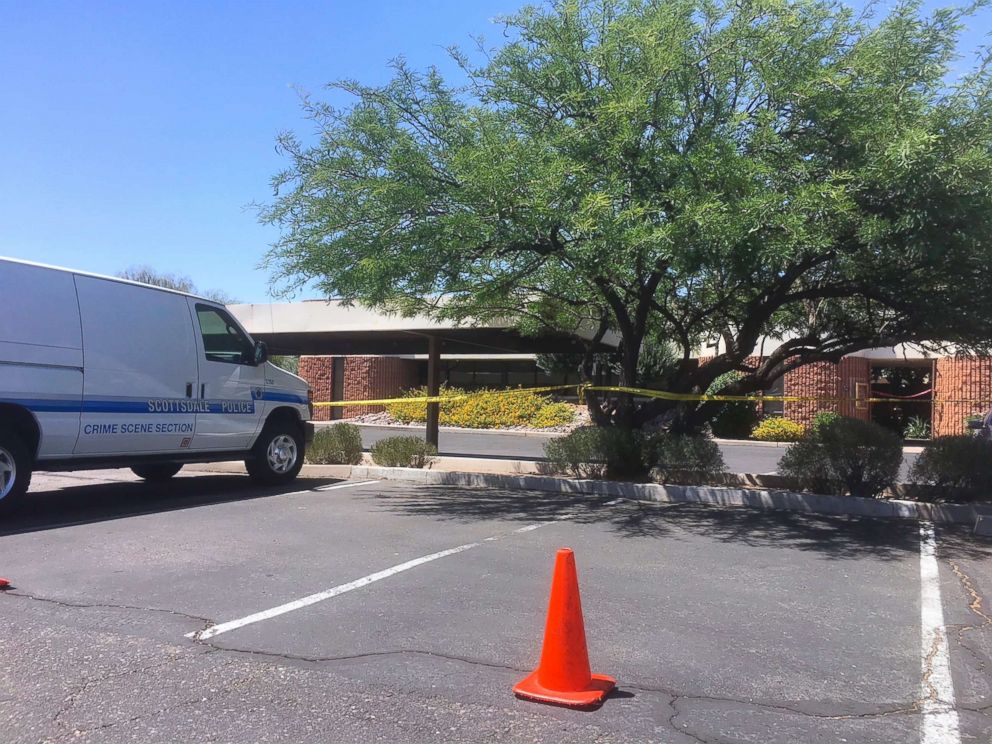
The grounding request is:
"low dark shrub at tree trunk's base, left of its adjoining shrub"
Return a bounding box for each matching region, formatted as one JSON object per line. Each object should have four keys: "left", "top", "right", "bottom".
{"left": 544, "top": 426, "right": 648, "bottom": 479}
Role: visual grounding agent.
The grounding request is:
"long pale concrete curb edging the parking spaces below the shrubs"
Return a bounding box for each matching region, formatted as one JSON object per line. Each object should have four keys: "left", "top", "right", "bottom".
{"left": 191, "top": 462, "right": 976, "bottom": 526}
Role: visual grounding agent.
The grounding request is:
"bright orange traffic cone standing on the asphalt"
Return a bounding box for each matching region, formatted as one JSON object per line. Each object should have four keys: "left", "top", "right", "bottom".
{"left": 513, "top": 548, "right": 617, "bottom": 708}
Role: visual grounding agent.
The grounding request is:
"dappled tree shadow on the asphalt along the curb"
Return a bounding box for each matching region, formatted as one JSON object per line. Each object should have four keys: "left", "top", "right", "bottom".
{"left": 375, "top": 486, "right": 992, "bottom": 560}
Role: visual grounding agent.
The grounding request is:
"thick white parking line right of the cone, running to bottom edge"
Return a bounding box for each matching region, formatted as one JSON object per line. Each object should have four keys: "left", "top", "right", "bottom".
{"left": 920, "top": 522, "right": 961, "bottom": 744}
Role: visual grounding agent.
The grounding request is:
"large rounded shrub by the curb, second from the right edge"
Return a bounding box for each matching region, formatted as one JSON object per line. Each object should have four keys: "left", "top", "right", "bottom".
{"left": 779, "top": 417, "right": 902, "bottom": 497}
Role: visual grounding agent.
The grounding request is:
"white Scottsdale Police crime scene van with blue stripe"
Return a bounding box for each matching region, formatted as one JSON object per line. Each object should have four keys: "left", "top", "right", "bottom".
{"left": 0, "top": 258, "right": 313, "bottom": 510}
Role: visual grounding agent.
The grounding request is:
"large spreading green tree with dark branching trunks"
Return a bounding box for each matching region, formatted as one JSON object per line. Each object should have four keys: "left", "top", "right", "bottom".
{"left": 263, "top": 0, "right": 992, "bottom": 428}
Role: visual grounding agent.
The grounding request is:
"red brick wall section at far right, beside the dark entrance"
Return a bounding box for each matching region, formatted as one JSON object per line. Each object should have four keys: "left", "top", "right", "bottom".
{"left": 933, "top": 357, "right": 992, "bottom": 436}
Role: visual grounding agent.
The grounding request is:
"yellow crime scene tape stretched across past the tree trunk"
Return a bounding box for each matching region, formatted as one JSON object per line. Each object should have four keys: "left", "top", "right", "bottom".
{"left": 313, "top": 384, "right": 992, "bottom": 408}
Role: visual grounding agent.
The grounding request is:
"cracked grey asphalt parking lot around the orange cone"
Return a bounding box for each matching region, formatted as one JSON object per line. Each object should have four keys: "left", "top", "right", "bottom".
{"left": 0, "top": 471, "right": 992, "bottom": 744}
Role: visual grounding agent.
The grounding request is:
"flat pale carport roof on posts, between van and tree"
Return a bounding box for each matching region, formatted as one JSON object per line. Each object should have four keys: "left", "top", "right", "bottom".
{"left": 229, "top": 300, "right": 619, "bottom": 356}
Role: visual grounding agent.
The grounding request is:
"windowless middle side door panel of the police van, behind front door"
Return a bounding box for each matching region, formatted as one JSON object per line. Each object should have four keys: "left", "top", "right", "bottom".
{"left": 75, "top": 274, "right": 199, "bottom": 455}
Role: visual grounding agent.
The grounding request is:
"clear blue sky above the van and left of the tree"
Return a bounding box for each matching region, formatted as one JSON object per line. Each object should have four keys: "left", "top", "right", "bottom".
{"left": 0, "top": 0, "right": 989, "bottom": 302}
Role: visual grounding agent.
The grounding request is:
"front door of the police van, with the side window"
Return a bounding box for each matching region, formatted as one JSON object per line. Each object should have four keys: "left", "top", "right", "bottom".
{"left": 189, "top": 298, "right": 265, "bottom": 450}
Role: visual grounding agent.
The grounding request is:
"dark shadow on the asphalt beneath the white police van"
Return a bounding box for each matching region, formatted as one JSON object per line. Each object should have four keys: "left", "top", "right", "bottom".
{"left": 0, "top": 475, "right": 340, "bottom": 537}
